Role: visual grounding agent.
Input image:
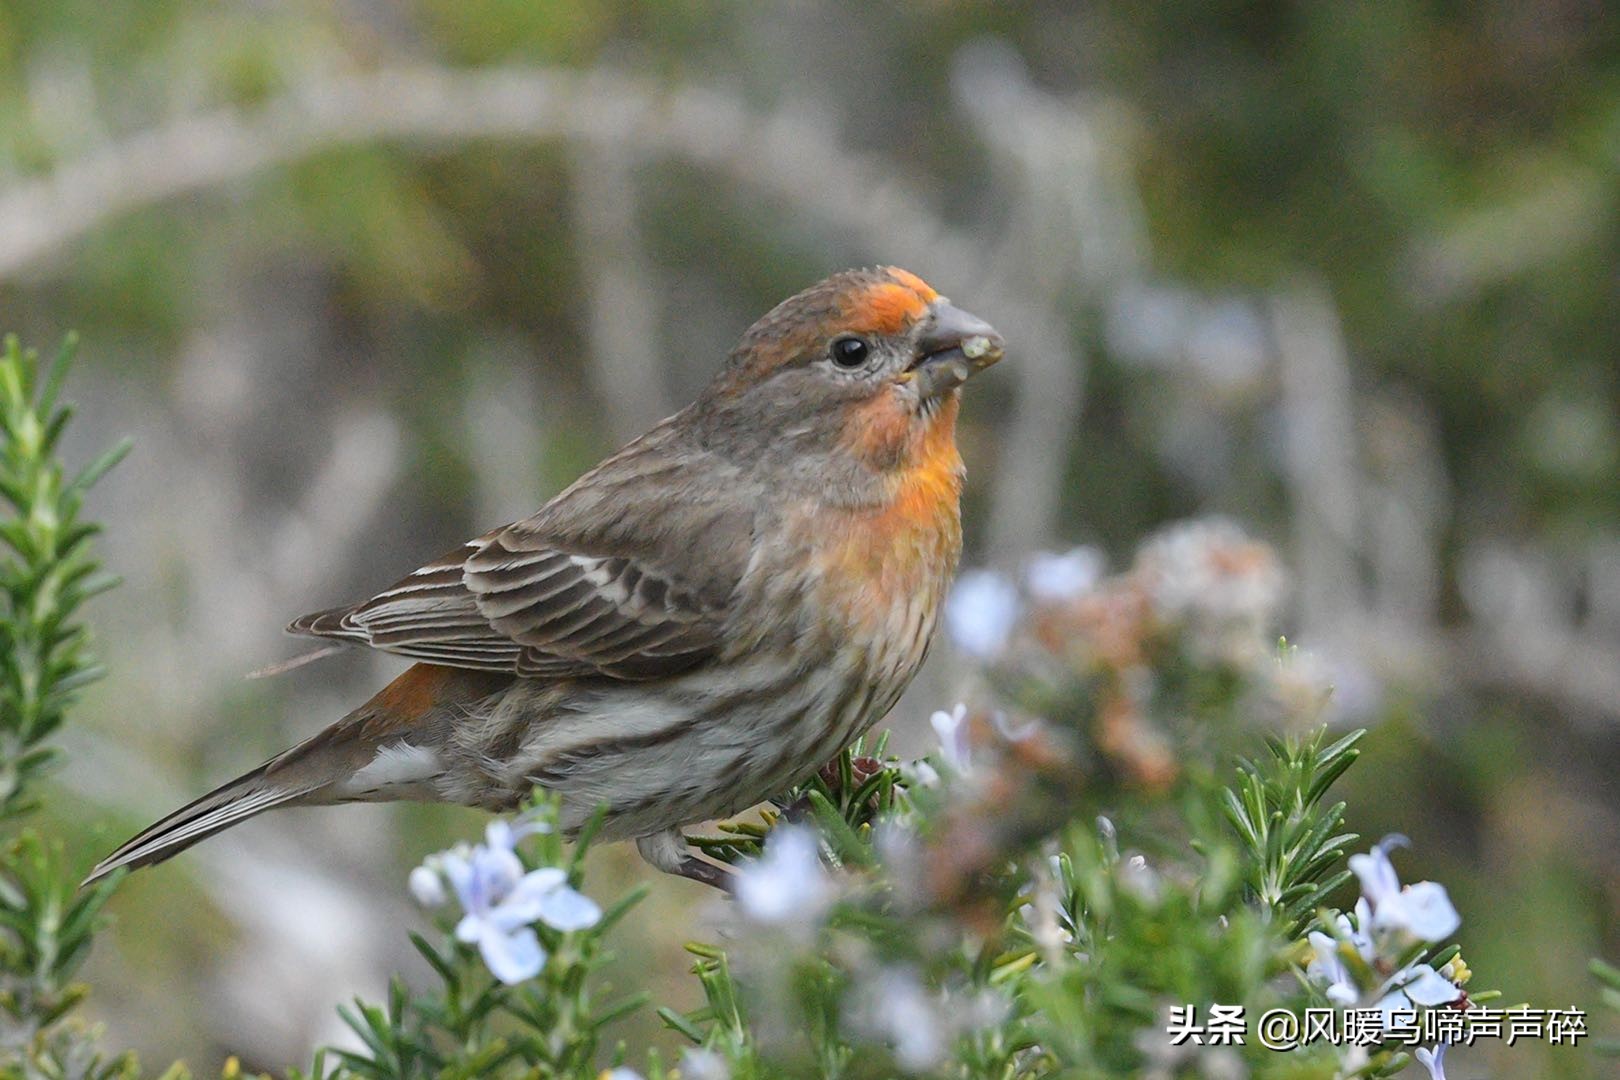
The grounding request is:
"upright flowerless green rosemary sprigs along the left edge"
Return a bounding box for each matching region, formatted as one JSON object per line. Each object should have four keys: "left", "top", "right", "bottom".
{"left": 0, "top": 337, "right": 130, "bottom": 1078}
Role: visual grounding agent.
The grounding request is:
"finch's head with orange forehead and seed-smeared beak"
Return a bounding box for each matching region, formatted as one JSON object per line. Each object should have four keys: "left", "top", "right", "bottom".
{"left": 693, "top": 267, "right": 1003, "bottom": 502}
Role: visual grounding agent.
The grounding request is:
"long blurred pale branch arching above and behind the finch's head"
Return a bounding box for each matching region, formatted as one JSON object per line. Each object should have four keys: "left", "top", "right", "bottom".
{"left": 0, "top": 66, "right": 1079, "bottom": 546}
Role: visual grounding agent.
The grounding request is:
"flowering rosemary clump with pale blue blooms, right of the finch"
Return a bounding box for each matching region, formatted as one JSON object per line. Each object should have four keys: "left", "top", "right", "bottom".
{"left": 648, "top": 537, "right": 1503, "bottom": 1078}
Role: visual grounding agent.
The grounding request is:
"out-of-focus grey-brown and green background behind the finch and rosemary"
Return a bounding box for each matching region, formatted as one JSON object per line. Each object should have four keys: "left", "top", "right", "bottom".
{"left": 0, "top": 0, "right": 1620, "bottom": 1075}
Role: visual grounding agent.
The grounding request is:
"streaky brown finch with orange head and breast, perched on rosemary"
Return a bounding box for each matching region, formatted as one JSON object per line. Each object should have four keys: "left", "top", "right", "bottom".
{"left": 91, "top": 267, "right": 1001, "bottom": 884}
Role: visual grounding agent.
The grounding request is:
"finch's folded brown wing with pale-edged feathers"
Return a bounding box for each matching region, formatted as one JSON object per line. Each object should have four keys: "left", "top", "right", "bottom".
{"left": 288, "top": 426, "right": 753, "bottom": 678}
